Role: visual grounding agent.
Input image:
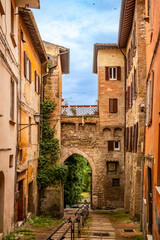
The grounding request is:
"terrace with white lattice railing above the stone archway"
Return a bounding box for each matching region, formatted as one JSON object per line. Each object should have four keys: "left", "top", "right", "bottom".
{"left": 61, "top": 105, "right": 99, "bottom": 117}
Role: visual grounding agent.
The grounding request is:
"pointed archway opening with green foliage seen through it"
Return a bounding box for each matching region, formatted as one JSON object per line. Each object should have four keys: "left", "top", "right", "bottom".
{"left": 64, "top": 154, "right": 92, "bottom": 208}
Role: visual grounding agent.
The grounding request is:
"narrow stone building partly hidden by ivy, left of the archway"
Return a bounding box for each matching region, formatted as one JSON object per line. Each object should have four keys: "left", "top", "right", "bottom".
{"left": 39, "top": 41, "right": 70, "bottom": 216}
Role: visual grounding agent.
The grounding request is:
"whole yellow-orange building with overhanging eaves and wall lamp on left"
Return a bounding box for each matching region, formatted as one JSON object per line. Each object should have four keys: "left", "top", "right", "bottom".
{"left": 16, "top": 8, "right": 47, "bottom": 225}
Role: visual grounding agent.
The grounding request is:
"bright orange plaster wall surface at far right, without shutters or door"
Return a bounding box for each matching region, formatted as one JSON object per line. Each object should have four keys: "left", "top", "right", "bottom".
{"left": 144, "top": 0, "right": 160, "bottom": 240}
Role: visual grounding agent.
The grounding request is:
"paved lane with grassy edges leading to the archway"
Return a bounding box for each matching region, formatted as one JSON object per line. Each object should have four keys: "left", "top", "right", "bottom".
{"left": 11, "top": 208, "right": 144, "bottom": 240}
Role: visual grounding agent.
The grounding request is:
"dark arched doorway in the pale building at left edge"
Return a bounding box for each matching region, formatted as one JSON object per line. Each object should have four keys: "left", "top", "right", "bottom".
{"left": 0, "top": 172, "right": 4, "bottom": 233}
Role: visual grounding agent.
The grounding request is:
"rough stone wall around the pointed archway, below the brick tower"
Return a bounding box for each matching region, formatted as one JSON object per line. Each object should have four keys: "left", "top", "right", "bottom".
{"left": 61, "top": 117, "right": 124, "bottom": 209}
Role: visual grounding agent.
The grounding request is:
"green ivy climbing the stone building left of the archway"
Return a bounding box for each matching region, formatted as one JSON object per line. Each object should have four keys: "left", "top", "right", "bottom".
{"left": 37, "top": 100, "right": 68, "bottom": 189}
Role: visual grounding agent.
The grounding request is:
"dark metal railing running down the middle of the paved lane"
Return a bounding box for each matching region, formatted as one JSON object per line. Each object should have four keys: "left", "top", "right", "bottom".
{"left": 45, "top": 202, "right": 89, "bottom": 240}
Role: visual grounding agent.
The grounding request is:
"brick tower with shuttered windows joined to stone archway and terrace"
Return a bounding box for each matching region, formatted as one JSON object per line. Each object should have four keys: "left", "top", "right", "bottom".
{"left": 61, "top": 44, "right": 124, "bottom": 209}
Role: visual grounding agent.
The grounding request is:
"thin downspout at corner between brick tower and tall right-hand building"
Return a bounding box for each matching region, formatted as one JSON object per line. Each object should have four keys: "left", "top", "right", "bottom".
{"left": 118, "top": 45, "right": 126, "bottom": 171}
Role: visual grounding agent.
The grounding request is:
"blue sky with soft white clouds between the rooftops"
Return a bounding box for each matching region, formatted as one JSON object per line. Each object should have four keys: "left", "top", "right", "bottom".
{"left": 33, "top": 0, "right": 121, "bottom": 105}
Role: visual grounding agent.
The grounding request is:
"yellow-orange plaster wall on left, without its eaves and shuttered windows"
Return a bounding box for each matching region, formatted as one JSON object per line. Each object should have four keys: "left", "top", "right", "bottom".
{"left": 17, "top": 12, "right": 42, "bottom": 221}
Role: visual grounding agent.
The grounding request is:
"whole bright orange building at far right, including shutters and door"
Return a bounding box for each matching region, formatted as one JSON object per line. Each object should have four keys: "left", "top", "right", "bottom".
{"left": 142, "top": 0, "right": 160, "bottom": 240}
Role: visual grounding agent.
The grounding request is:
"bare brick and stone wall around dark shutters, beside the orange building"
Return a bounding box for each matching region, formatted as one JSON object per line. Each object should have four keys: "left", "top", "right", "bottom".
{"left": 124, "top": 0, "right": 146, "bottom": 220}
